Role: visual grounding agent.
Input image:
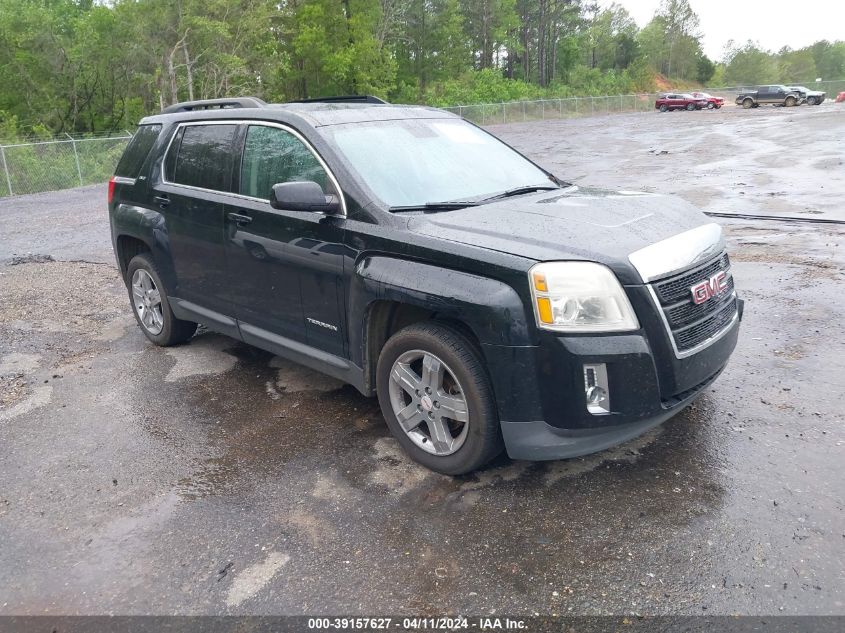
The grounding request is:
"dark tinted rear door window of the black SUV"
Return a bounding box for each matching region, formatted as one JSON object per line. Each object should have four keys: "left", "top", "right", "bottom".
{"left": 171, "top": 125, "right": 236, "bottom": 191}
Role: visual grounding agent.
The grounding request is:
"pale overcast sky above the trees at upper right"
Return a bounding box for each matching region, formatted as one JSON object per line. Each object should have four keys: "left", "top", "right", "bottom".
{"left": 601, "top": 0, "right": 845, "bottom": 61}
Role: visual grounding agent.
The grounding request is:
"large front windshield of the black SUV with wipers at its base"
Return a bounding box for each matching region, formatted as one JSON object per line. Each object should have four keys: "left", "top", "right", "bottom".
{"left": 318, "top": 119, "right": 556, "bottom": 207}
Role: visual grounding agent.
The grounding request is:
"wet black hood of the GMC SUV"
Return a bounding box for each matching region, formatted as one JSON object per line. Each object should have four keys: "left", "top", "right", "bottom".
{"left": 409, "top": 186, "right": 711, "bottom": 284}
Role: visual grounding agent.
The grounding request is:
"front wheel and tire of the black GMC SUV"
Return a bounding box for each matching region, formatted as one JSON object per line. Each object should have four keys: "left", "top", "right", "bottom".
{"left": 376, "top": 322, "right": 504, "bottom": 475}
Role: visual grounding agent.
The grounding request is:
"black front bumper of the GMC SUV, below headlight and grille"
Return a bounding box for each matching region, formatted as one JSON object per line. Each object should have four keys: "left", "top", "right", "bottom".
{"left": 485, "top": 300, "right": 743, "bottom": 460}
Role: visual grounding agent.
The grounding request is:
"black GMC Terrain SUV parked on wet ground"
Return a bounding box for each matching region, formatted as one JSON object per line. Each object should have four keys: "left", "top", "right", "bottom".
{"left": 109, "top": 98, "right": 742, "bottom": 474}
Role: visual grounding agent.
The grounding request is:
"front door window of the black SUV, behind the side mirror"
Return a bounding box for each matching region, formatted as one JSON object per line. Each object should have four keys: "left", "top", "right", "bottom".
{"left": 239, "top": 125, "right": 328, "bottom": 200}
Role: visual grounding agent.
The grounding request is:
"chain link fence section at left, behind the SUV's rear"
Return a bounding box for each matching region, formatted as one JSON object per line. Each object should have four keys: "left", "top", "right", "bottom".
{"left": 0, "top": 132, "right": 132, "bottom": 197}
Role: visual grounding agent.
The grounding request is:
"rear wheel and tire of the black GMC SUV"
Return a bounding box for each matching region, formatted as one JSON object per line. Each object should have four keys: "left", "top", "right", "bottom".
{"left": 126, "top": 253, "right": 197, "bottom": 347}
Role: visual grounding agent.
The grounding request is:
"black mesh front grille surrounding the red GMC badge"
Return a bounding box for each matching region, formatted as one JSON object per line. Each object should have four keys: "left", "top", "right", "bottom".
{"left": 652, "top": 253, "right": 737, "bottom": 354}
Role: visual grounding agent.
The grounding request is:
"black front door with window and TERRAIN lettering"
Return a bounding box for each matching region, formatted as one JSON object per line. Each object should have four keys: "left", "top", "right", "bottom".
{"left": 225, "top": 125, "right": 346, "bottom": 356}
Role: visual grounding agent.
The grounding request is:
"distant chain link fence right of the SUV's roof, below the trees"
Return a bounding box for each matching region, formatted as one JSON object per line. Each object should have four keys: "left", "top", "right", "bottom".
{"left": 443, "top": 80, "right": 845, "bottom": 125}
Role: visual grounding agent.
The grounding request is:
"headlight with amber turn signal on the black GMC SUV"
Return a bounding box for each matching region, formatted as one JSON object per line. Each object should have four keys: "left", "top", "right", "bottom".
{"left": 528, "top": 262, "right": 640, "bottom": 332}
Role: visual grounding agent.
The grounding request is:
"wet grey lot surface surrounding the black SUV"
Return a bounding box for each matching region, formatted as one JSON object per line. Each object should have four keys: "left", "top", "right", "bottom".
{"left": 0, "top": 104, "right": 845, "bottom": 615}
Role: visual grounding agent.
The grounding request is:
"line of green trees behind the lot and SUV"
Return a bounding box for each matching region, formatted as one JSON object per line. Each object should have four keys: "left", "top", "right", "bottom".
{"left": 0, "top": 0, "right": 845, "bottom": 138}
